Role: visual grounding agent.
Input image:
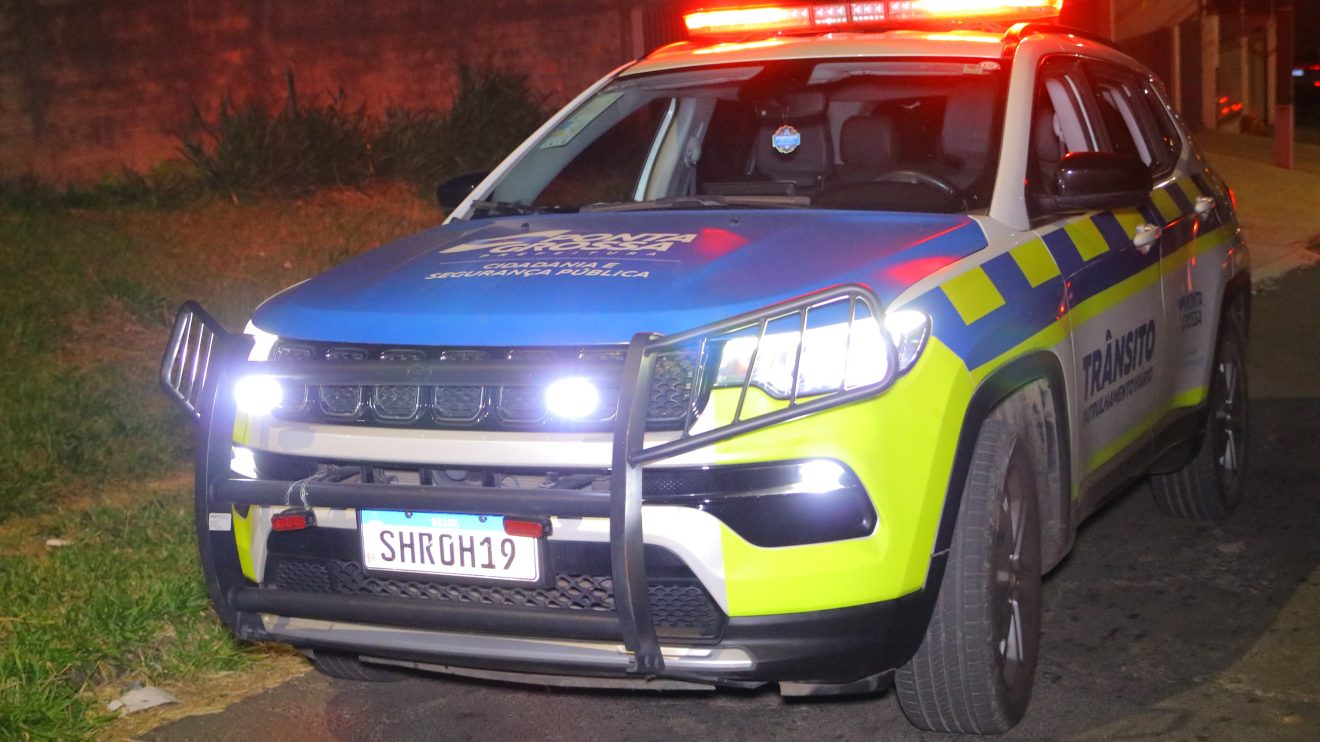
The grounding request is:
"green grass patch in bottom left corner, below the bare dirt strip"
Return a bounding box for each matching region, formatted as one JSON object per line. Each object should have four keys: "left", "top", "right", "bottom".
{"left": 0, "top": 492, "right": 252, "bottom": 739}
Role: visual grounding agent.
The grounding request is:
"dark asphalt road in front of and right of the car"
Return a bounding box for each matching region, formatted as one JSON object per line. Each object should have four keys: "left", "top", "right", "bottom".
{"left": 147, "top": 269, "right": 1320, "bottom": 742}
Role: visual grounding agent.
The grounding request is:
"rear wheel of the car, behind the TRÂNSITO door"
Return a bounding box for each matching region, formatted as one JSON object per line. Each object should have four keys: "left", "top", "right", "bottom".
{"left": 1151, "top": 306, "right": 1247, "bottom": 520}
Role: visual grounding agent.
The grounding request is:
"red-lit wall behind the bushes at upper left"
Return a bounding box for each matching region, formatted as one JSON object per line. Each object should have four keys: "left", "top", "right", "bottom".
{"left": 0, "top": 0, "right": 655, "bottom": 181}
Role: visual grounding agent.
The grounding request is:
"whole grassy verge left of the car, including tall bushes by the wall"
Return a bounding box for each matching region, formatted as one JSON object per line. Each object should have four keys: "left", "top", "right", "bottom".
{"left": 0, "top": 70, "right": 544, "bottom": 739}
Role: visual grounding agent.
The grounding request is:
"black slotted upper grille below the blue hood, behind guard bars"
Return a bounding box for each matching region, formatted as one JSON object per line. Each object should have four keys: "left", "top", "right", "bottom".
{"left": 271, "top": 341, "right": 700, "bottom": 430}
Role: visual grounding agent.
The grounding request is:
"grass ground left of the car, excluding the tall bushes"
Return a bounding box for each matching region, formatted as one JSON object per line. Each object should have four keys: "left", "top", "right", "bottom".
{"left": 0, "top": 178, "right": 441, "bottom": 739}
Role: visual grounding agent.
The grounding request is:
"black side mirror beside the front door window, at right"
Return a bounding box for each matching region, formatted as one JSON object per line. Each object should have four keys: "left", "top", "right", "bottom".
{"left": 1041, "top": 152, "right": 1155, "bottom": 211}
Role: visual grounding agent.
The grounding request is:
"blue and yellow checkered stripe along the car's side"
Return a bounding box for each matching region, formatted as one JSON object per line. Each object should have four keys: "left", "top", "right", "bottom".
{"left": 913, "top": 177, "right": 1220, "bottom": 368}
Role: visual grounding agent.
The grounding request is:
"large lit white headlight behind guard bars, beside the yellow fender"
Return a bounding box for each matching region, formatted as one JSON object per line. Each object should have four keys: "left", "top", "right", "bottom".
{"left": 715, "top": 310, "right": 931, "bottom": 399}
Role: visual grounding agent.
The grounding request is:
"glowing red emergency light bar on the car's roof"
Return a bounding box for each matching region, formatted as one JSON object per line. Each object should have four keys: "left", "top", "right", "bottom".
{"left": 682, "top": 0, "right": 1063, "bottom": 37}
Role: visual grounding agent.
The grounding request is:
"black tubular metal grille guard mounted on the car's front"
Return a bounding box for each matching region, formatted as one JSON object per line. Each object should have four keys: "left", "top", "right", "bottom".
{"left": 161, "top": 285, "right": 896, "bottom": 676}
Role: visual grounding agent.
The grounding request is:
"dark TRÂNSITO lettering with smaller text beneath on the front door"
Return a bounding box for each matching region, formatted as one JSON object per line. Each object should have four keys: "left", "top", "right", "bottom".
{"left": 1081, "top": 320, "right": 1155, "bottom": 422}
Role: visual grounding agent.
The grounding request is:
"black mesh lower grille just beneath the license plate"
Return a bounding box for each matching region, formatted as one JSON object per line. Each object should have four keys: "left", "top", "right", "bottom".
{"left": 265, "top": 555, "right": 723, "bottom": 638}
